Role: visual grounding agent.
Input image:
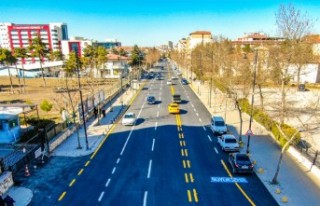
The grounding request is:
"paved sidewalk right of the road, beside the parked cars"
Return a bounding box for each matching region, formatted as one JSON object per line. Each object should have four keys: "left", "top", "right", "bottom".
{"left": 190, "top": 82, "right": 320, "bottom": 206}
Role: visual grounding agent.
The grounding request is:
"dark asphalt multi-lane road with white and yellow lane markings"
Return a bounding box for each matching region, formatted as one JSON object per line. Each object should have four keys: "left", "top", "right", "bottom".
{"left": 55, "top": 67, "right": 277, "bottom": 206}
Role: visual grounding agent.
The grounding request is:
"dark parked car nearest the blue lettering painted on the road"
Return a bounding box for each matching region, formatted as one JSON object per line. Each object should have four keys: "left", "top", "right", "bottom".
{"left": 229, "top": 153, "right": 254, "bottom": 173}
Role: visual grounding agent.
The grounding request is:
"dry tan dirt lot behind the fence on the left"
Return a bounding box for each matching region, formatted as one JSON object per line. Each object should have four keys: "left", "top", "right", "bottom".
{"left": 0, "top": 76, "right": 119, "bottom": 122}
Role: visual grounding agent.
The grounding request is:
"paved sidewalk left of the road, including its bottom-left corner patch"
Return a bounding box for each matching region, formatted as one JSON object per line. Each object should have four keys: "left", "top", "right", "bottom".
{"left": 3, "top": 86, "right": 138, "bottom": 206}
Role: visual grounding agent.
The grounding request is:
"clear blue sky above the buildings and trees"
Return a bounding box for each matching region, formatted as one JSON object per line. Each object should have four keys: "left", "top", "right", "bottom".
{"left": 0, "top": 0, "right": 320, "bottom": 46}
